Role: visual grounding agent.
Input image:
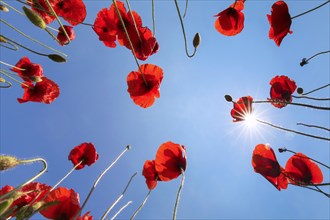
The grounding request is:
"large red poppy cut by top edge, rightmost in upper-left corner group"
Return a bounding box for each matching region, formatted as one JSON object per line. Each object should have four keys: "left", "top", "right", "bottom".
{"left": 51, "top": 0, "right": 87, "bottom": 26}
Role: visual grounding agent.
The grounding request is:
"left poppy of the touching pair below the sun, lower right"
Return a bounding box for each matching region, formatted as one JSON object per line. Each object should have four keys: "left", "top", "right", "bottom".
{"left": 252, "top": 144, "right": 288, "bottom": 190}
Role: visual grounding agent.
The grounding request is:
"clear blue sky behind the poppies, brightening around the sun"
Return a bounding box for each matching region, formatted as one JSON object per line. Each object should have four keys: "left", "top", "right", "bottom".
{"left": 0, "top": 0, "right": 330, "bottom": 219}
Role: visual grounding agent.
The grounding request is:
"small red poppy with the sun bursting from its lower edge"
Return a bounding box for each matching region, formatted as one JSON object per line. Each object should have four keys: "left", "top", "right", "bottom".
{"left": 230, "top": 96, "right": 253, "bottom": 122}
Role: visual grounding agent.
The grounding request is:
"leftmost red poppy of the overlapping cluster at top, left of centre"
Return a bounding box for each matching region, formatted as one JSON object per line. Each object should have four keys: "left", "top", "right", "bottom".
{"left": 93, "top": 8, "right": 117, "bottom": 48}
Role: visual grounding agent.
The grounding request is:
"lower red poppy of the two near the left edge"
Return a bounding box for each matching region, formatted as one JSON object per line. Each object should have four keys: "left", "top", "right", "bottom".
{"left": 17, "top": 77, "right": 60, "bottom": 104}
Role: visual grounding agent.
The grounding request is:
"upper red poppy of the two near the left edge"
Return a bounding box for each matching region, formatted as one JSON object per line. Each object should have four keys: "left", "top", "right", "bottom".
{"left": 11, "top": 57, "right": 44, "bottom": 82}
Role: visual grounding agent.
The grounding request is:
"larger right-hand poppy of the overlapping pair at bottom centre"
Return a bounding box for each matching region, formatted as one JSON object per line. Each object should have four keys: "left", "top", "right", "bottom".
{"left": 155, "top": 141, "right": 187, "bottom": 181}
